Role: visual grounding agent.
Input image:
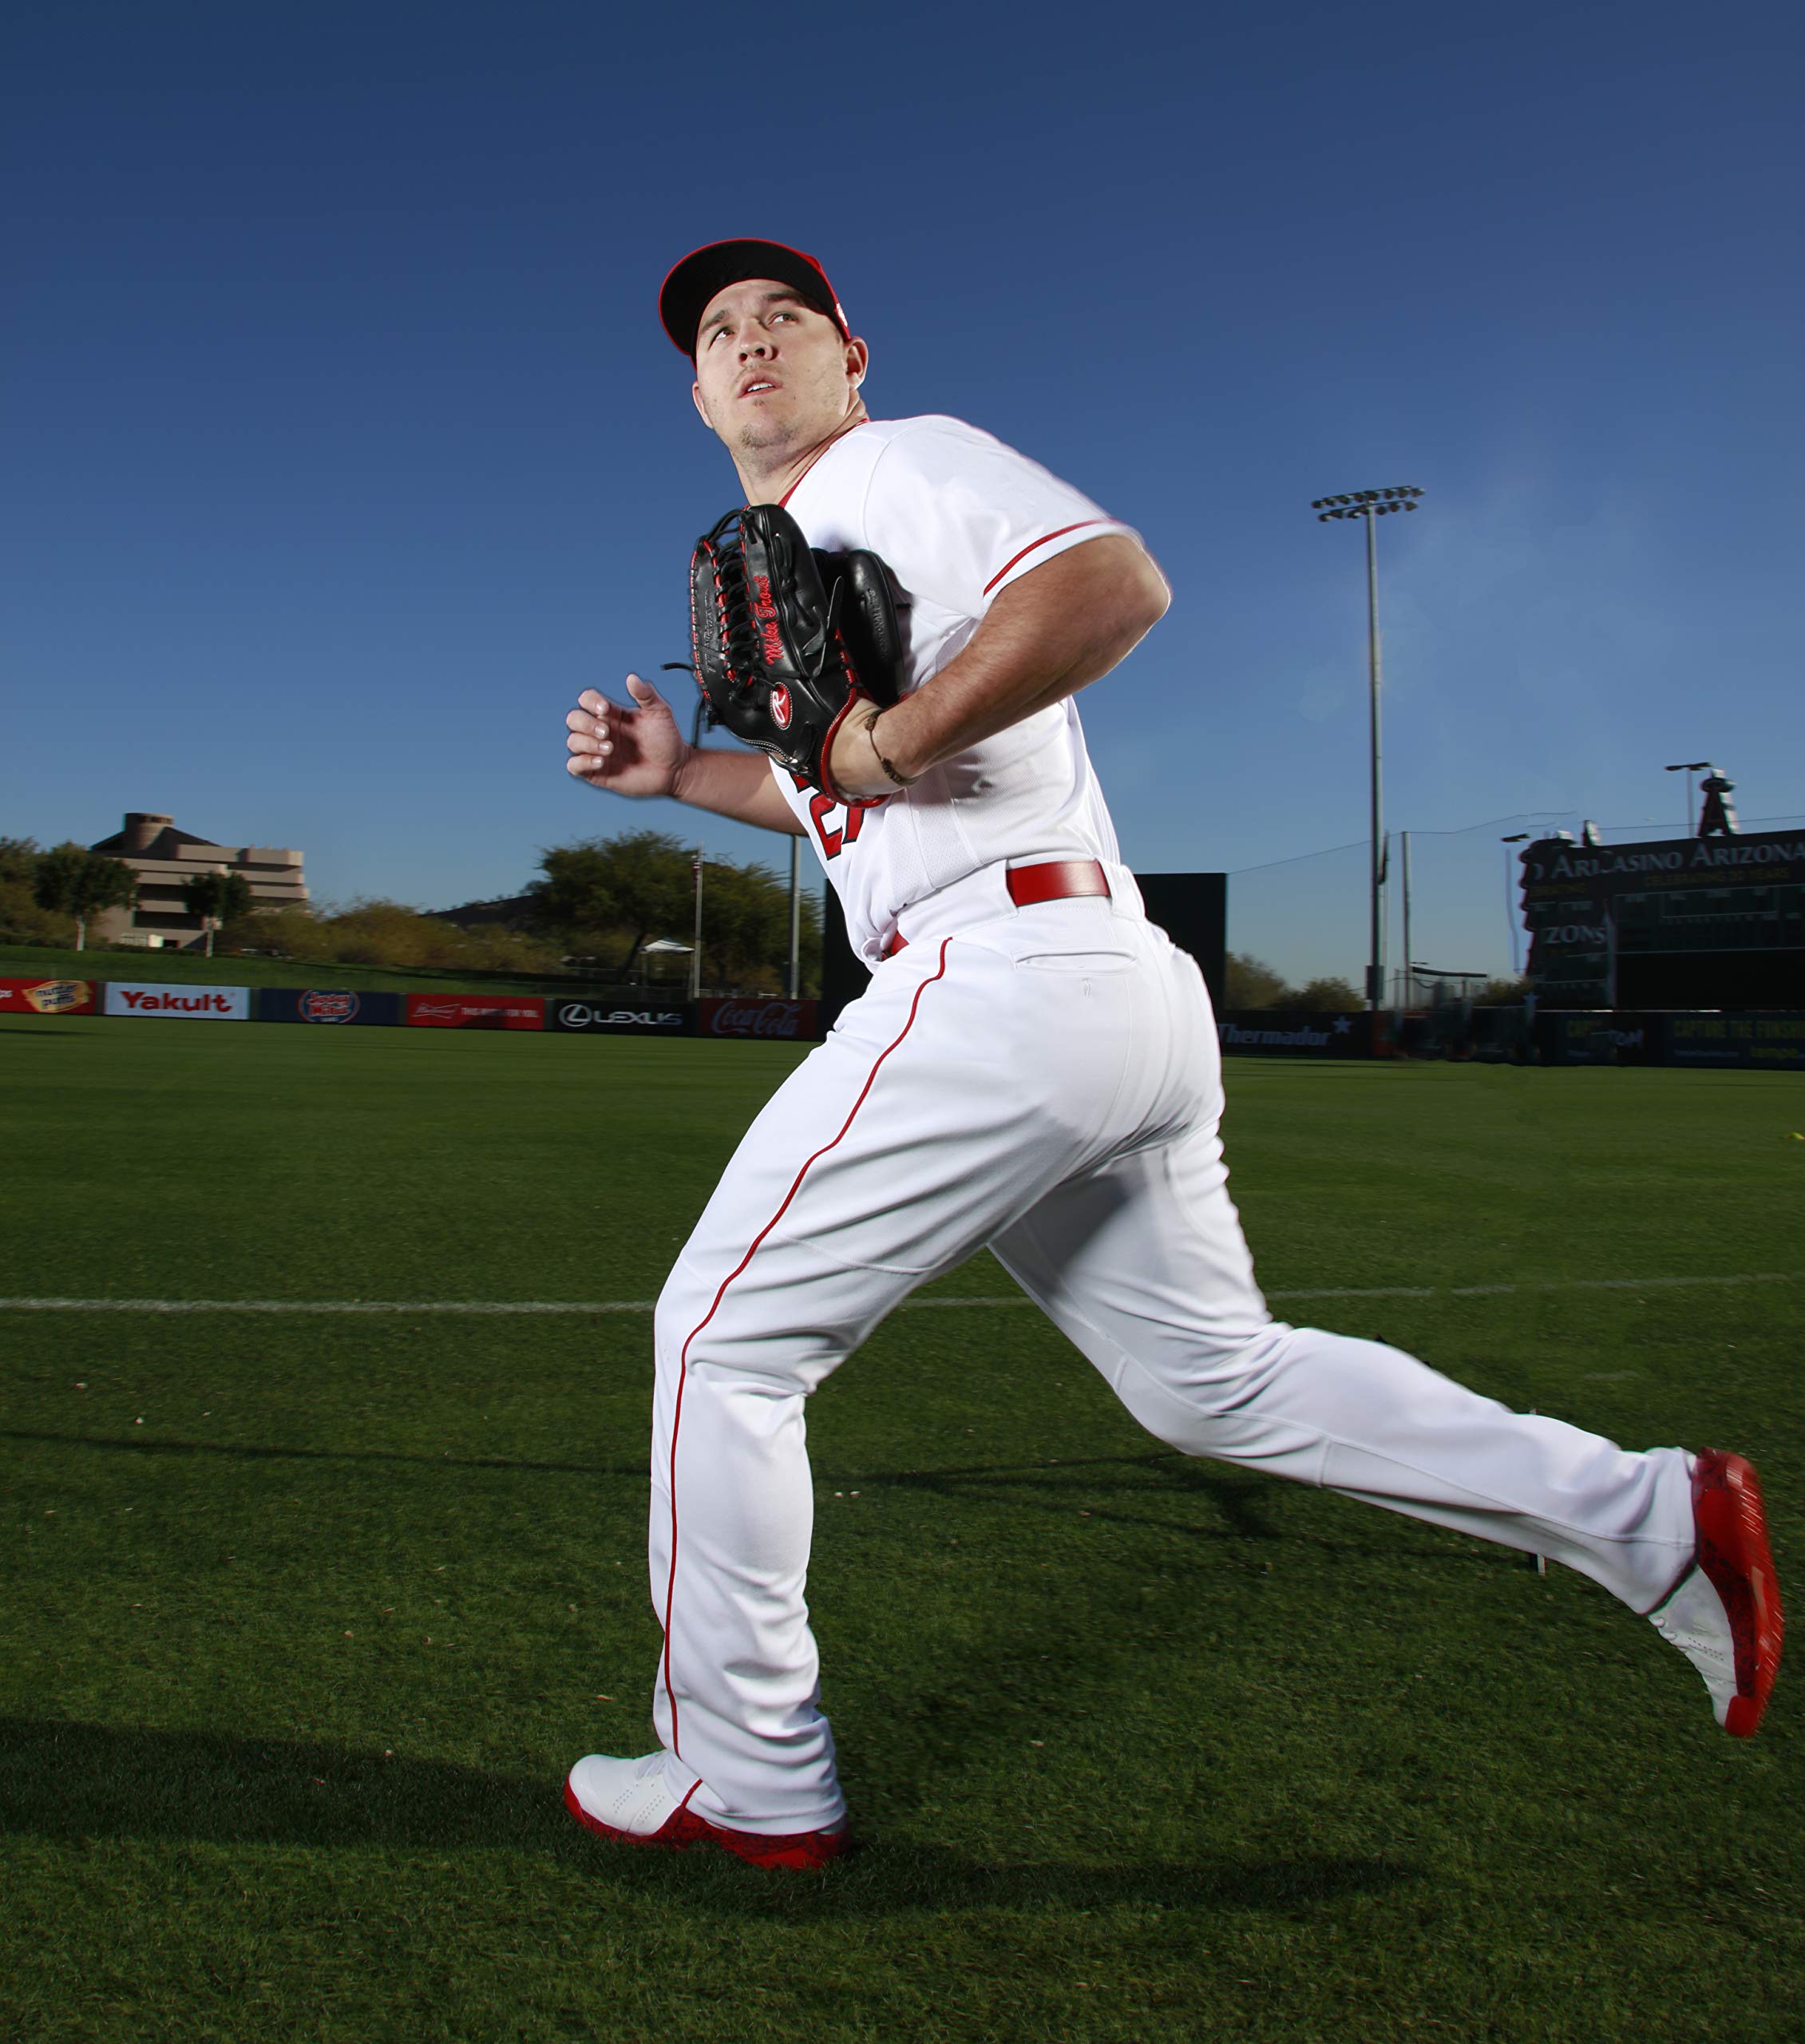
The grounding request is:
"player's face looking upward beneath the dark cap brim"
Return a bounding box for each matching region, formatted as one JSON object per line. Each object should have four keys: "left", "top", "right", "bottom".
{"left": 693, "top": 278, "right": 865, "bottom": 454}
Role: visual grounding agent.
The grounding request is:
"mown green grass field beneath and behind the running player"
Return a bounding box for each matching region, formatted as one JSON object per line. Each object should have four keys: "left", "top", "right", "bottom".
{"left": 0, "top": 1018, "right": 1805, "bottom": 2044}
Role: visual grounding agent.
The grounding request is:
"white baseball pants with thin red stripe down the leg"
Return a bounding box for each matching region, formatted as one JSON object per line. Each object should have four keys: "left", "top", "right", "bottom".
{"left": 650, "top": 869, "right": 1692, "bottom": 1832}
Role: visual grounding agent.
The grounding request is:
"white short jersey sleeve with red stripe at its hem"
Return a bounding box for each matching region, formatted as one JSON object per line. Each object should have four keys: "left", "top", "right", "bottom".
{"left": 863, "top": 419, "right": 1133, "bottom": 617}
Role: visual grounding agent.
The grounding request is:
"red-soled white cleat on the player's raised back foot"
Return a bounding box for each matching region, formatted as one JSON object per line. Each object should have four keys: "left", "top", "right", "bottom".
{"left": 1649, "top": 1447, "right": 1787, "bottom": 1740}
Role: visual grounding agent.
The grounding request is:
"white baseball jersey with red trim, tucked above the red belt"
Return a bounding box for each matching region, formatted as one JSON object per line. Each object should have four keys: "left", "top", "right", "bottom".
{"left": 773, "top": 417, "right": 1128, "bottom": 965}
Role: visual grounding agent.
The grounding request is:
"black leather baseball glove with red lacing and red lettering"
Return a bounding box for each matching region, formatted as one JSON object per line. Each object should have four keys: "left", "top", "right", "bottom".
{"left": 689, "top": 505, "right": 904, "bottom": 802}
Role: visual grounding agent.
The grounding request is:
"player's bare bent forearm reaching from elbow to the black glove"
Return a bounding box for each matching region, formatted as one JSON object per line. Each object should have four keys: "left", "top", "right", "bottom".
{"left": 854, "top": 533, "right": 1171, "bottom": 795}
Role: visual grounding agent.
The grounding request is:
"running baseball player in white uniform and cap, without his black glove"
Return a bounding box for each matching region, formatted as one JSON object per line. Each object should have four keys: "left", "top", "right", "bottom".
{"left": 566, "top": 241, "right": 1780, "bottom": 1866}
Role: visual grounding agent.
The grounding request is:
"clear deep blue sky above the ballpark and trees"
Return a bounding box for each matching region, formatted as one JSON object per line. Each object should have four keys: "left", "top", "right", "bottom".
{"left": 0, "top": 0, "right": 1805, "bottom": 973}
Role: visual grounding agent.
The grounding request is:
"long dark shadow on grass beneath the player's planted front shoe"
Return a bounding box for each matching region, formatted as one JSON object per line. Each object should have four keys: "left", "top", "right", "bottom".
{"left": 0, "top": 1717, "right": 1419, "bottom": 1915}
